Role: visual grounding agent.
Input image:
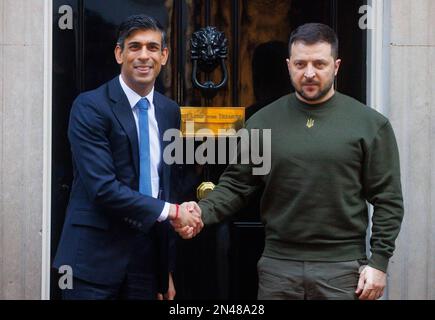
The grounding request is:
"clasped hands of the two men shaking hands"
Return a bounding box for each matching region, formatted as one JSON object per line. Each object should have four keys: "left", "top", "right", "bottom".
{"left": 169, "top": 201, "right": 204, "bottom": 239}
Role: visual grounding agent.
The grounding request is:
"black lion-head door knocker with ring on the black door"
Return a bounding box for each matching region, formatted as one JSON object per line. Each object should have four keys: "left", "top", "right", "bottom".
{"left": 190, "top": 26, "right": 228, "bottom": 99}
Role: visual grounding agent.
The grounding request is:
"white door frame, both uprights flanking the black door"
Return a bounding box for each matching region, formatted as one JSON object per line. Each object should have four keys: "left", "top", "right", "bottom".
{"left": 41, "top": 0, "right": 391, "bottom": 300}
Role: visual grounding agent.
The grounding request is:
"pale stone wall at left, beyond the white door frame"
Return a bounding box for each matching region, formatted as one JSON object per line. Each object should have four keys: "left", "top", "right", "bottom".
{"left": 0, "top": 0, "right": 45, "bottom": 299}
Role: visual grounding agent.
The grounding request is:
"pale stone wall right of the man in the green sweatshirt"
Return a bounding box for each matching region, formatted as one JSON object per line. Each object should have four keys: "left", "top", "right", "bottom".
{"left": 386, "top": 0, "right": 435, "bottom": 299}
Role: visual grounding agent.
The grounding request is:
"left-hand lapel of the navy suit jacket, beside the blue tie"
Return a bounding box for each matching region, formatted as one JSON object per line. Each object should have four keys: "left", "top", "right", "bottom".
{"left": 108, "top": 77, "right": 139, "bottom": 176}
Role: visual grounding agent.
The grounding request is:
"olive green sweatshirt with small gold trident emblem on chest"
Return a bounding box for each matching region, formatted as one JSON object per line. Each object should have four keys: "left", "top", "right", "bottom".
{"left": 199, "top": 92, "right": 403, "bottom": 271}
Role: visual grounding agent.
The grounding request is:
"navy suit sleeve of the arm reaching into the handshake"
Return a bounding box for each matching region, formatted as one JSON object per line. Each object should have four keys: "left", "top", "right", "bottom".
{"left": 68, "top": 95, "right": 164, "bottom": 232}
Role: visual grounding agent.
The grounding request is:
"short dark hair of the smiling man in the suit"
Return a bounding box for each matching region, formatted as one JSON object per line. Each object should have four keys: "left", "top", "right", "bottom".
{"left": 116, "top": 14, "right": 166, "bottom": 50}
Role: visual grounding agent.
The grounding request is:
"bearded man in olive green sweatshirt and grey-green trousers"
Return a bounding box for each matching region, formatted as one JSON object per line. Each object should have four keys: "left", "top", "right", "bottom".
{"left": 179, "top": 23, "right": 403, "bottom": 300}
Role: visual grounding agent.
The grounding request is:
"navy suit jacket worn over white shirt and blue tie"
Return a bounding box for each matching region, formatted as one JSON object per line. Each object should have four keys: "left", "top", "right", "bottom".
{"left": 54, "top": 77, "right": 180, "bottom": 292}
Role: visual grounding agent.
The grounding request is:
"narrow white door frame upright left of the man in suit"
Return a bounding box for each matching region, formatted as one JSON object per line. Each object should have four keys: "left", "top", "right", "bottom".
{"left": 41, "top": 0, "right": 53, "bottom": 300}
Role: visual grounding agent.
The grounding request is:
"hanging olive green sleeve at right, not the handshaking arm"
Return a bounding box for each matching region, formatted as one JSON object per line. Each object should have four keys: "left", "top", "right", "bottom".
{"left": 363, "top": 121, "right": 403, "bottom": 272}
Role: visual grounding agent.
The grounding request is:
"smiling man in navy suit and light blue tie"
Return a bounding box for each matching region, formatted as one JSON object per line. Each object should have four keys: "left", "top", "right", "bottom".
{"left": 54, "top": 15, "right": 202, "bottom": 299}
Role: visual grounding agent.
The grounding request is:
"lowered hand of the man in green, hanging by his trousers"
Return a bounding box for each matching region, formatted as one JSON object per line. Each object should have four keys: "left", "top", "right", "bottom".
{"left": 355, "top": 266, "right": 387, "bottom": 300}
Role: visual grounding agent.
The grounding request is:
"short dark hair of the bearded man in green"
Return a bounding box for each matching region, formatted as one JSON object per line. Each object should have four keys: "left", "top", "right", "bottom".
{"left": 288, "top": 23, "right": 338, "bottom": 59}
